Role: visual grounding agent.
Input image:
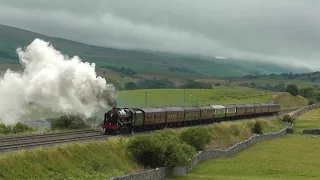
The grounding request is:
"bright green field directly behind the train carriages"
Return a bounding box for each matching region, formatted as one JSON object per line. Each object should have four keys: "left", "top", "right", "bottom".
{"left": 117, "top": 87, "right": 272, "bottom": 107}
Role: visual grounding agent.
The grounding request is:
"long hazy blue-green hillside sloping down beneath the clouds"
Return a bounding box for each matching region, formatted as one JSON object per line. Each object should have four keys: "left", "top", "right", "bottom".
{"left": 0, "top": 25, "right": 307, "bottom": 79}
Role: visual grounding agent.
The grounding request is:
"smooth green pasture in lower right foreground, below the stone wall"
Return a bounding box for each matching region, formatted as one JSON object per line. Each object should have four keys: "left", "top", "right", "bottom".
{"left": 168, "top": 135, "right": 320, "bottom": 180}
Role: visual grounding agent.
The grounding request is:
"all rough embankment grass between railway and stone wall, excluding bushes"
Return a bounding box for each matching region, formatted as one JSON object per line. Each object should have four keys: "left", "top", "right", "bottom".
{"left": 0, "top": 114, "right": 285, "bottom": 180}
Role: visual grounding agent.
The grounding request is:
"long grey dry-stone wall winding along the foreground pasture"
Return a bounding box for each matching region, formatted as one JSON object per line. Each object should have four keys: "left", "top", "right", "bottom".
{"left": 110, "top": 103, "right": 320, "bottom": 180}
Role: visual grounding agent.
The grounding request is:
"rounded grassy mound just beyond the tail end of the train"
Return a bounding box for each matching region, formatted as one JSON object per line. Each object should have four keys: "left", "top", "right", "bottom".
{"left": 274, "top": 92, "right": 308, "bottom": 110}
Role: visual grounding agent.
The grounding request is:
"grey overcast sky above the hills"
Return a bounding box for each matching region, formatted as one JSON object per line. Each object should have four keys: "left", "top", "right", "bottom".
{"left": 0, "top": 0, "right": 320, "bottom": 70}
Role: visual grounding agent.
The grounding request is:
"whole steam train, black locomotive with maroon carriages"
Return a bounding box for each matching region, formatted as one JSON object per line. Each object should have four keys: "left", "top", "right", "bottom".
{"left": 101, "top": 103, "right": 281, "bottom": 135}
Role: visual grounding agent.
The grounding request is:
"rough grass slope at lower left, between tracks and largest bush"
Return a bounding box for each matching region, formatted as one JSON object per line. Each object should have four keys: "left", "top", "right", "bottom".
{"left": 0, "top": 138, "right": 140, "bottom": 180}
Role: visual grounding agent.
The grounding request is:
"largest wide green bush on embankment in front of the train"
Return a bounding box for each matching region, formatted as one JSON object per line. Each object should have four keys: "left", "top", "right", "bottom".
{"left": 127, "top": 130, "right": 195, "bottom": 168}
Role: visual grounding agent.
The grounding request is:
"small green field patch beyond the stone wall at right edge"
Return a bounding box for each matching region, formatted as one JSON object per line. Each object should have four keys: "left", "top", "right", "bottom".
{"left": 294, "top": 108, "right": 320, "bottom": 133}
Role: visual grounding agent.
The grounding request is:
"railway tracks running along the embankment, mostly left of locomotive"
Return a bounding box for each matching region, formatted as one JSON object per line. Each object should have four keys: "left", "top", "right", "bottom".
{"left": 0, "top": 109, "right": 297, "bottom": 154}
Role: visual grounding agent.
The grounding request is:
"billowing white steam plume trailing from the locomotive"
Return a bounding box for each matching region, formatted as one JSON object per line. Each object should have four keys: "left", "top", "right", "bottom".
{"left": 0, "top": 39, "right": 116, "bottom": 124}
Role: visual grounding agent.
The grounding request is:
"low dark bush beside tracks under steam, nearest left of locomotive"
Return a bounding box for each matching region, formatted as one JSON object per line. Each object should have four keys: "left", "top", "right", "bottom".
{"left": 51, "top": 115, "right": 89, "bottom": 129}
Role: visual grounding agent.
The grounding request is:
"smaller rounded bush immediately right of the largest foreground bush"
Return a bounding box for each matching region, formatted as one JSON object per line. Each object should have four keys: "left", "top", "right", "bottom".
{"left": 180, "top": 127, "right": 212, "bottom": 151}
